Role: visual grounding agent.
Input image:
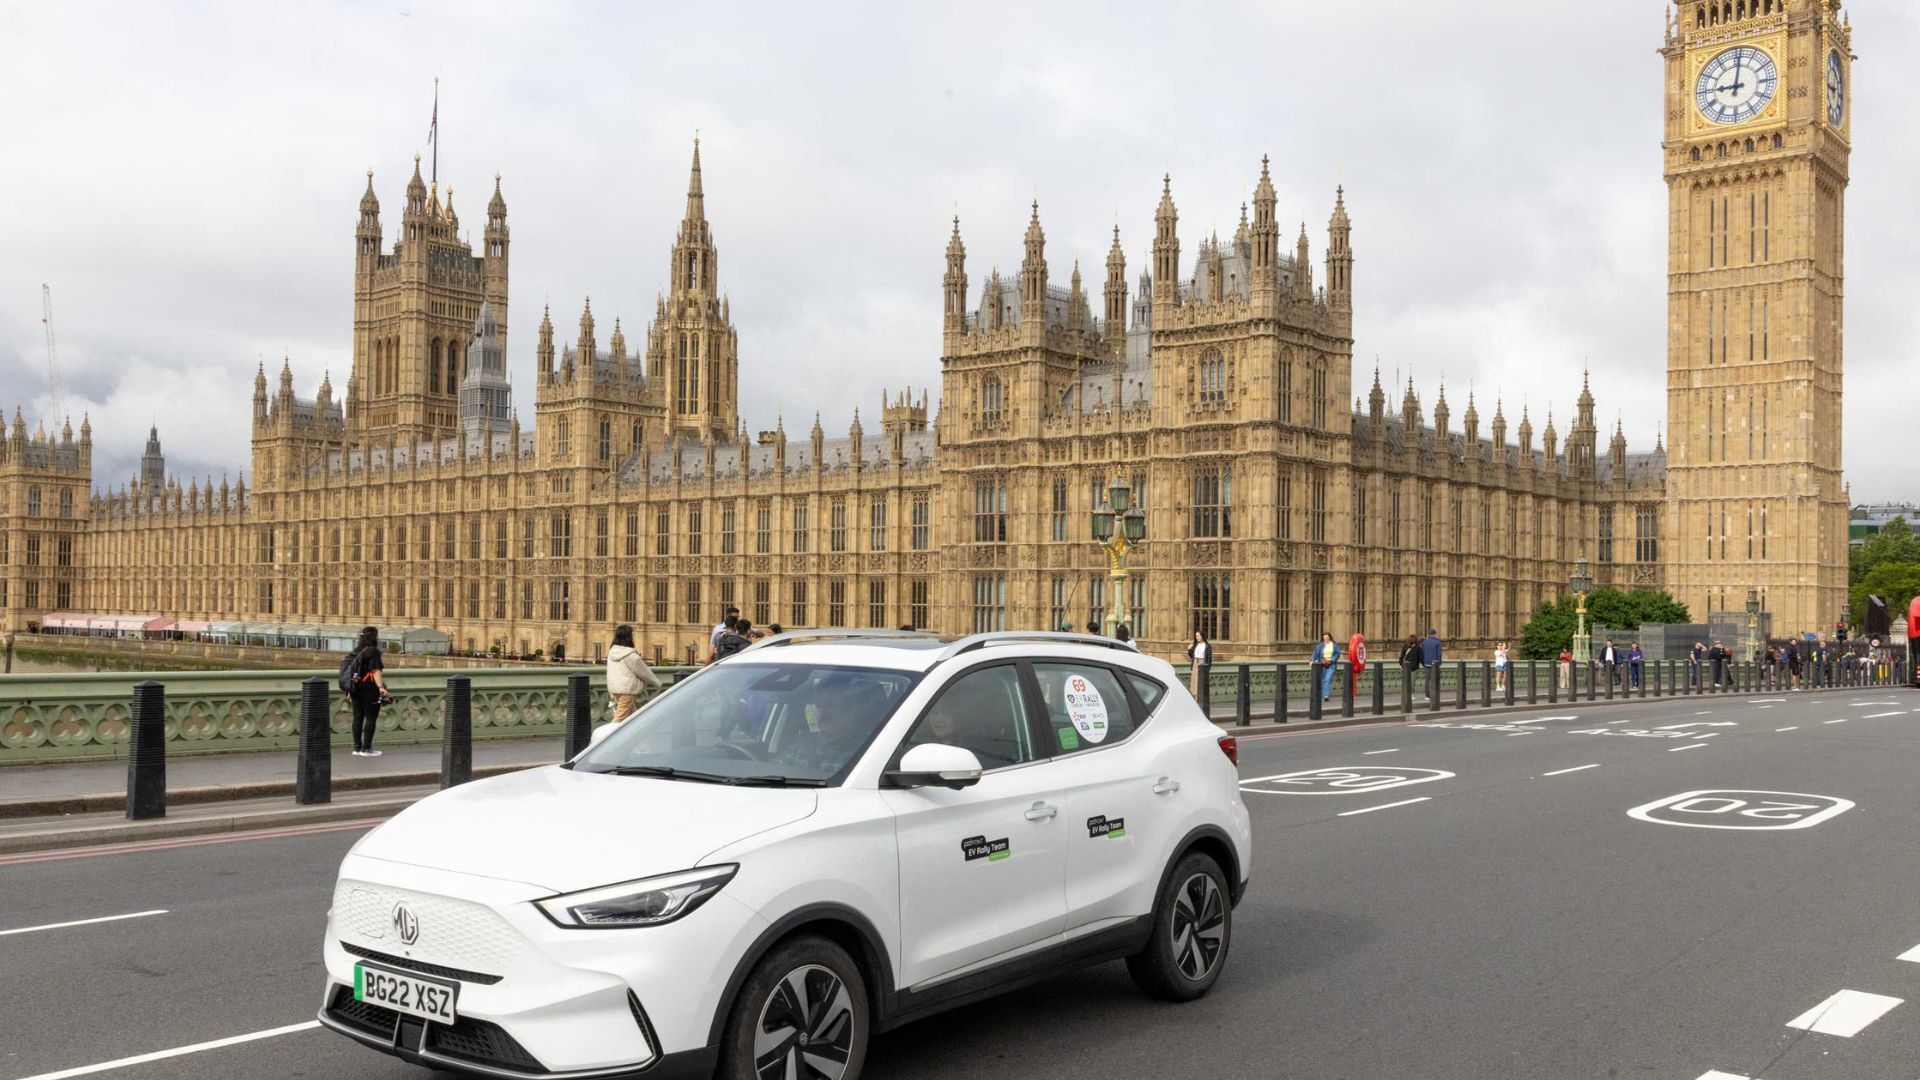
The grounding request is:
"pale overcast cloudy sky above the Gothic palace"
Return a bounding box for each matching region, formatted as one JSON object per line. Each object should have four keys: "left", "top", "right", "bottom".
{"left": 0, "top": 0, "right": 1920, "bottom": 500}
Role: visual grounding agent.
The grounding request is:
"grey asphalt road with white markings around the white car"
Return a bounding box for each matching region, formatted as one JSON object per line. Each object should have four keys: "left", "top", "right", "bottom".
{"left": 0, "top": 688, "right": 1920, "bottom": 1080}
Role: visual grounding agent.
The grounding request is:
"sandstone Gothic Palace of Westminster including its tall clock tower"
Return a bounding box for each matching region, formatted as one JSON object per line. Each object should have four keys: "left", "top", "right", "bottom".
{"left": 0, "top": 0, "right": 1853, "bottom": 661}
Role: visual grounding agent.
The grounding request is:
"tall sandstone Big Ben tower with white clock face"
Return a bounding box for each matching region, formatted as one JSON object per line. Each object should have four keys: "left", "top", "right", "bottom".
{"left": 1661, "top": 0, "right": 1853, "bottom": 636}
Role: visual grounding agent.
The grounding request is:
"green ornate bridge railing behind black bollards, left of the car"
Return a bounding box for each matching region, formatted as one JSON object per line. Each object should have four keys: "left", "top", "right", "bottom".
{"left": 0, "top": 665, "right": 691, "bottom": 767}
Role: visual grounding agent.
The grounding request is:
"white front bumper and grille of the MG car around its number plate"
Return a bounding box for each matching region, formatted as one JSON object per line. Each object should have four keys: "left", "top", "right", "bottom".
{"left": 319, "top": 855, "right": 760, "bottom": 1080}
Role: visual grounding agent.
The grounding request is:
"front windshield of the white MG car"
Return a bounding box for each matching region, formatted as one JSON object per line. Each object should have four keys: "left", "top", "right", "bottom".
{"left": 574, "top": 659, "right": 920, "bottom": 786}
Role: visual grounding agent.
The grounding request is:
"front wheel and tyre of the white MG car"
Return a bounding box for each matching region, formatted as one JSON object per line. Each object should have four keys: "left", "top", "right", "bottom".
{"left": 716, "top": 934, "right": 870, "bottom": 1080}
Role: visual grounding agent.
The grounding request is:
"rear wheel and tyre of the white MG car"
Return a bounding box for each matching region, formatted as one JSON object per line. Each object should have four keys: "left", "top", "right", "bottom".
{"left": 1127, "top": 851, "right": 1233, "bottom": 1001}
